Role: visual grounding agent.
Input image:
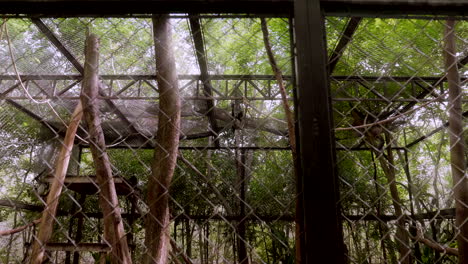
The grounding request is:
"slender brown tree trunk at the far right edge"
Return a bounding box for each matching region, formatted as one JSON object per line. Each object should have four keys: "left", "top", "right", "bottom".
{"left": 444, "top": 20, "right": 468, "bottom": 264}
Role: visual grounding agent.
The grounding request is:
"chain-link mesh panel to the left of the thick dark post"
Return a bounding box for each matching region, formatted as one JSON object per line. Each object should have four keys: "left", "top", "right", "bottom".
{"left": 0, "top": 15, "right": 295, "bottom": 263}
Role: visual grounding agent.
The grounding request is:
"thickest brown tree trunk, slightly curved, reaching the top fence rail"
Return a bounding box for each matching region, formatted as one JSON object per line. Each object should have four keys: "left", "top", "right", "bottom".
{"left": 144, "top": 15, "right": 181, "bottom": 264}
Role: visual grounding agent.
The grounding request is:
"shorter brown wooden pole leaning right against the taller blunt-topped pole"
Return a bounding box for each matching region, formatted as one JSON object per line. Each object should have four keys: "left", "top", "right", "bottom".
{"left": 30, "top": 103, "right": 83, "bottom": 264}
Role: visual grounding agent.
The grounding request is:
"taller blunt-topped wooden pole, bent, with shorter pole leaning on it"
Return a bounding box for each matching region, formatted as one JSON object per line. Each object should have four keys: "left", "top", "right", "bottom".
{"left": 81, "top": 35, "right": 132, "bottom": 264}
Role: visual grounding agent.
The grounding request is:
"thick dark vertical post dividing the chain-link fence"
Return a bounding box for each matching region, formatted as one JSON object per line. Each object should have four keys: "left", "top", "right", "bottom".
{"left": 294, "top": 0, "right": 345, "bottom": 264}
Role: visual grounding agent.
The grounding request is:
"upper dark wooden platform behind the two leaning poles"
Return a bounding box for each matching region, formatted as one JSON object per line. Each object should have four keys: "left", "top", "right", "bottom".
{"left": 41, "top": 175, "right": 139, "bottom": 195}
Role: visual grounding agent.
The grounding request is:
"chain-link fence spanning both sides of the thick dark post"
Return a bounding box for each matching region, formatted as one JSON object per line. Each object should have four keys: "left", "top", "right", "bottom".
{"left": 0, "top": 7, "right": 468, "bottom": 263}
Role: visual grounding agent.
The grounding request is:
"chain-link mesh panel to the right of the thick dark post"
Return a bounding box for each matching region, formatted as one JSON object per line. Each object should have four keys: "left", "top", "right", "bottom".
{"left": 326, "top": 17, "right": 468, "bottom": 263}
